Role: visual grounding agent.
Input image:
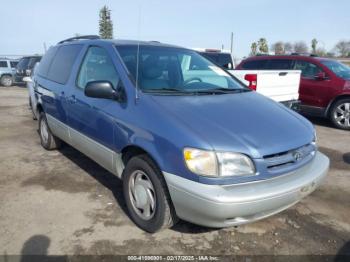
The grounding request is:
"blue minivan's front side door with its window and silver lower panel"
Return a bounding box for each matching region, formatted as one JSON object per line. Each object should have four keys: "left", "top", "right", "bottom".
{"left": 68, "top": 46, "right": 120, "bottom": 172}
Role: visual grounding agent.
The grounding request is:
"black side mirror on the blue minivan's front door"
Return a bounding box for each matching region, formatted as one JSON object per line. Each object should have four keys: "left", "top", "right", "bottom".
{"left": 84, "top": 81, "right": 124, "bottom": 102}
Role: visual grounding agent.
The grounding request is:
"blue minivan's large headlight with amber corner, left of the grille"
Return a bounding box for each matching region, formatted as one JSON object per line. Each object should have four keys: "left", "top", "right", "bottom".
{"left": 184, "top": 148, "right": 255, "bottom": 177}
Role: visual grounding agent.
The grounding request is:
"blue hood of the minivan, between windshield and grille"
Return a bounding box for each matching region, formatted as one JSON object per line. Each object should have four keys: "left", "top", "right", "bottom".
{"left": 152, "top": 92, "right": 314, "bottom": 158}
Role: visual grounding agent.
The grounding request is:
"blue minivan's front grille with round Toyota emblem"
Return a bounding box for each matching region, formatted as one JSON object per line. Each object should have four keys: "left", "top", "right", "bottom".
{"left": 264, "top": 143, "right": 316, "bottom": 170}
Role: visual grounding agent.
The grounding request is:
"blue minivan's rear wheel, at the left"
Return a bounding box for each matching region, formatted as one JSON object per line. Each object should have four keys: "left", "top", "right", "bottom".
{"left": 39, "top": 112, "right": 62, "bottom": 150}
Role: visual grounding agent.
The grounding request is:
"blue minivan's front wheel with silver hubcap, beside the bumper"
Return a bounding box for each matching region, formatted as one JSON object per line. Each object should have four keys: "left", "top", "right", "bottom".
{"left": 123, "top": 154, "right": 178, "bottom": 233}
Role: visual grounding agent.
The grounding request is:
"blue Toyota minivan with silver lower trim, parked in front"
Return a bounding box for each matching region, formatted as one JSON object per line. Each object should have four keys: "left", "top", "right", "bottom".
{"left": 33, "top": 36, "right": 329, "bottom": 232}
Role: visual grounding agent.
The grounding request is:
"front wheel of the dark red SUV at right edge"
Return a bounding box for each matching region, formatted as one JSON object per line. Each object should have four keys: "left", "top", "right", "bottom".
{"left": 329, "top": 98, "right": 350, "bottom": 130}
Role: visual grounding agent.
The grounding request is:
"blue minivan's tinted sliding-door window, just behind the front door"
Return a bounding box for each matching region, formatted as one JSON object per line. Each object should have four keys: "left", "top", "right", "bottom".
{"left": 46, "top": 45, "right": 82, "bottom": 85}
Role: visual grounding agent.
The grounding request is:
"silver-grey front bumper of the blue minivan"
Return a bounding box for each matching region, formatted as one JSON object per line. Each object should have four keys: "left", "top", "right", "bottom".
{"left": 164, "top": 152, "right": 329, "bottom": 227}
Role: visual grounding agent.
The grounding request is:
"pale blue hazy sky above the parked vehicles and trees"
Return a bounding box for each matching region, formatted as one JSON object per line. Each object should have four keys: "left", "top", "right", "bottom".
{"left": 0, "top": 0, "right": 350, "bottom": 57}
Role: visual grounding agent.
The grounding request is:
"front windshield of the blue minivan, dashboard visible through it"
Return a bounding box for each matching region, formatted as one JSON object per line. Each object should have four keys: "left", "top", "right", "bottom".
{"left": 116, "top": 45, "right": 249, "bottom": 94}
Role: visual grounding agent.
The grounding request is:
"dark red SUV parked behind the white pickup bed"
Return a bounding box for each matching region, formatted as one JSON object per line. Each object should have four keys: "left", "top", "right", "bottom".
{"left": 236, "top": 55, "right": 350, "bottom": 130}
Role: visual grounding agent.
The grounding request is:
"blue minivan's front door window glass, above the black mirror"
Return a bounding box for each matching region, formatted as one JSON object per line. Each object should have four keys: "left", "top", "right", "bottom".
{"left": 77, "top": 46, "right": 119, "bottom": 89}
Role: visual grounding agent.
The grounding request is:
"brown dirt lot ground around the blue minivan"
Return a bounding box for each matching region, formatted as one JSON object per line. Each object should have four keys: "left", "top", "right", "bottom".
{"left": 0, "top": 87, "right": 350, "bottom": 260}
